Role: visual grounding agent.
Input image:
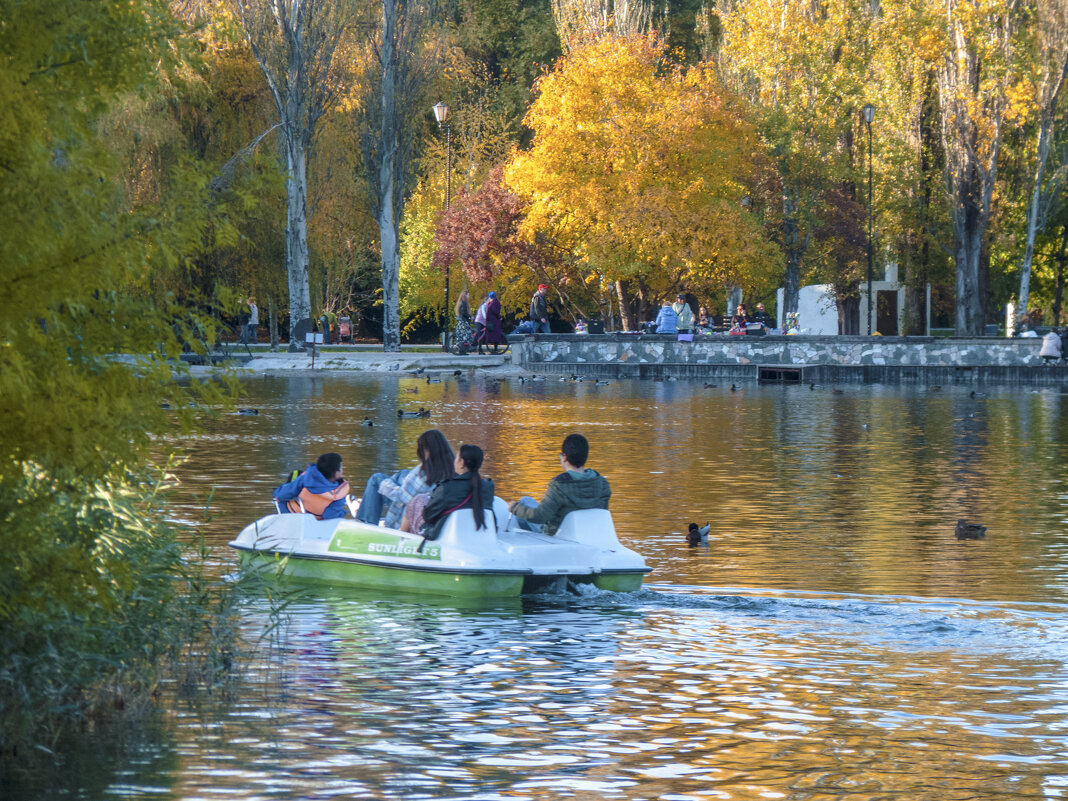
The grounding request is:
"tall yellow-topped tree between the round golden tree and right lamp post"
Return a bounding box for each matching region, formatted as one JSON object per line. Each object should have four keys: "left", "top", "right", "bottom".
{"left": 716, "top": 0, "right": 871, "bottom": 320}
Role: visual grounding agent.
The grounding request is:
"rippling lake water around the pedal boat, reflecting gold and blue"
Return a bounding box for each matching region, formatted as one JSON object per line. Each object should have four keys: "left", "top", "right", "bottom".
{"left": 8, "top": 375, "right": 1068, "bottom": 801}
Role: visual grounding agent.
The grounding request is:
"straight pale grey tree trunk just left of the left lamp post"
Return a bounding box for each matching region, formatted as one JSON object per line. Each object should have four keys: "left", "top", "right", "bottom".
{"left": 377, "top": 0, "right": 403, "bottom": 352}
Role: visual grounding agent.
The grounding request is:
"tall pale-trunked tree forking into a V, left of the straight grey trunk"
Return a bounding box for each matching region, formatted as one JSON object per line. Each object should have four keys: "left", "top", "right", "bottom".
{"left": 237, "top": 0, "right": 352, "bottom": 348}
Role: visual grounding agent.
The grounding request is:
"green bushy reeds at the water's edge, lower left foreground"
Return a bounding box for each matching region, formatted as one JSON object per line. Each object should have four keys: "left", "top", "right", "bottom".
{"left": 0, "top": 465, "right": 279, "bottom": 757}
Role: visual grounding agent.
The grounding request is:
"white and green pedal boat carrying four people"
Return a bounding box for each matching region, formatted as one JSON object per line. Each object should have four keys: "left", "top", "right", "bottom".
{"left": 230, "top": 498, "right": 650, "bottom": 598}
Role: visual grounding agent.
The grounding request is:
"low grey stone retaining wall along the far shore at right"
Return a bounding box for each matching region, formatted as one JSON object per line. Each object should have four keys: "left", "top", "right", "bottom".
{"left": 508, "top": 334, "right": 1068, "bottom": 384}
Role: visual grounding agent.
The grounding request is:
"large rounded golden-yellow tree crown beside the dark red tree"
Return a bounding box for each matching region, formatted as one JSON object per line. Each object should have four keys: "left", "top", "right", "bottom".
{"left": 505, "top": 35, "right": 780, "bottom": 324}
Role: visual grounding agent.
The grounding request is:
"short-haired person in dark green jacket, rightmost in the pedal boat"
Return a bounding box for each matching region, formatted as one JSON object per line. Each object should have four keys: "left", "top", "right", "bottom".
{"left": 508, "top": 434, "right": 612, "bottom": 534}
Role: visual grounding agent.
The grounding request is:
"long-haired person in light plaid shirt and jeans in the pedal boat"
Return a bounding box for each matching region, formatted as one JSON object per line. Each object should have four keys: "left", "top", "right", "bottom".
{"left": 356, "top": 428, "right": 453, "bottom": 529}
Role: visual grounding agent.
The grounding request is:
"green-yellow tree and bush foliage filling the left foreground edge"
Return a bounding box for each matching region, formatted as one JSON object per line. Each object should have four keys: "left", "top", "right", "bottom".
{"left": 0, "top": 0, "right": 245, "bottom": 753}
